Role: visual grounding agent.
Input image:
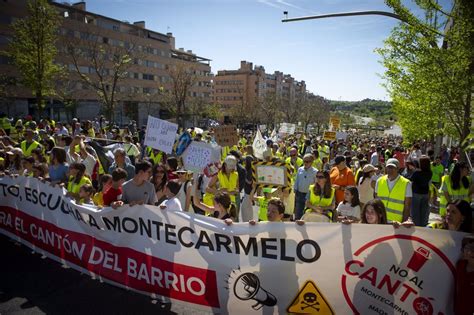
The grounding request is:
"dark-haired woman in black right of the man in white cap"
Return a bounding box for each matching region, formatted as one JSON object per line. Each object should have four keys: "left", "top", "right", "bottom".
{"left": 411, "top": 155, "right": 432, "bottom": 226}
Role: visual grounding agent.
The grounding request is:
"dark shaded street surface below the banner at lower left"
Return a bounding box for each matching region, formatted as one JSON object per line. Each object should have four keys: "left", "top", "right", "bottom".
{"left": 0, "top": 236, "right": 207, "bottom": 315}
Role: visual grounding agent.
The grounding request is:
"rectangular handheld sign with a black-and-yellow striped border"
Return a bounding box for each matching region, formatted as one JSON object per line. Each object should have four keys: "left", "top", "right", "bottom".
{"left": 252, "top": 162, "right": 291, "bottom": 191}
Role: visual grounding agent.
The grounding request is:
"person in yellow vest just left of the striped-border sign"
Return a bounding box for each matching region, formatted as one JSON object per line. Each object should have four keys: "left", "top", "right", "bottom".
{"left": 206, "top": 155, "right": 239, "bottom": 203}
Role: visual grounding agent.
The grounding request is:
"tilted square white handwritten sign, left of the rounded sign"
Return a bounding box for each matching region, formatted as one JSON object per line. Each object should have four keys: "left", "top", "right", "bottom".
{"left": 145, "top": 116, "right": 178, "bottom": 154}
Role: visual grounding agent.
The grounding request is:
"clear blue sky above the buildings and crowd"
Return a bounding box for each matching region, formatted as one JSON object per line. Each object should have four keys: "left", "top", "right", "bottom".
{"left": 86, "top": 0, "right": 450, "bottom": 101}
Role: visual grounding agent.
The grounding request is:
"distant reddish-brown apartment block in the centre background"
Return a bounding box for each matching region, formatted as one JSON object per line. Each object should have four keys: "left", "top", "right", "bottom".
{"left": 214, "top": 61, "right": 306, "bottom": 109}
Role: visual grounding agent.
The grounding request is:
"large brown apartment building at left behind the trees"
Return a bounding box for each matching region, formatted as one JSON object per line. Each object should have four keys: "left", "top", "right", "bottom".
{"left": 0, "top": 0, "right": 212, "bottom": 123}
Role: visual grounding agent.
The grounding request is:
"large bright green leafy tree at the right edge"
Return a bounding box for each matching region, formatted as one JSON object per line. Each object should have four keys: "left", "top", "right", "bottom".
{"left": 378, "top": 0, "right": 474, "bottom": 150}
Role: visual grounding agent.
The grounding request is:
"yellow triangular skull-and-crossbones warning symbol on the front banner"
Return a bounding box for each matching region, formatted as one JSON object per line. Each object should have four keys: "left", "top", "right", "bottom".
{"left": 286, "top": 280, "right": 334, "bottom": 315}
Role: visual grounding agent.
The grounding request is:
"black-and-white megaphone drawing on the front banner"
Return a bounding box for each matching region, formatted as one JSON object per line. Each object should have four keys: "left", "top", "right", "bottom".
{"left": 234, "top": 272, "right": 277, "bottom": 310}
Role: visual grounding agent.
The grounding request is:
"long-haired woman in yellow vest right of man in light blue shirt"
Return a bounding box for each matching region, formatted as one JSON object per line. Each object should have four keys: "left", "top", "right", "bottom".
{"left": 303, "top": 171, "right": 336, "bottom": 220}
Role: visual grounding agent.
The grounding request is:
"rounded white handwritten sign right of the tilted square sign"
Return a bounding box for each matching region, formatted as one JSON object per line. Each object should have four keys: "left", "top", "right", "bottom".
{"left": 181, "top": 141, "right": 220, "bottom": 172}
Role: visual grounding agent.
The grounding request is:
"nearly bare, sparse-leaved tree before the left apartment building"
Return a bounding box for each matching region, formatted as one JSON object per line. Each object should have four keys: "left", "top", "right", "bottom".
{"left": 67, "top": 28, "right": 135, "bottom": 124}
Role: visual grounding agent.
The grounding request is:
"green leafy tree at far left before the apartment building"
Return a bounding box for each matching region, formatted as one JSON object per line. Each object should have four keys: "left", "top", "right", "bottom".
{"left": 7, "top": 0, "right": 61, "bottom": 116}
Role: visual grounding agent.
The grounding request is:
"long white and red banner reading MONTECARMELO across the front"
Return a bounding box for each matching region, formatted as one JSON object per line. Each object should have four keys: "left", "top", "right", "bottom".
{"left": 0, "top": 177, "right": 467, "bottom": 315}
